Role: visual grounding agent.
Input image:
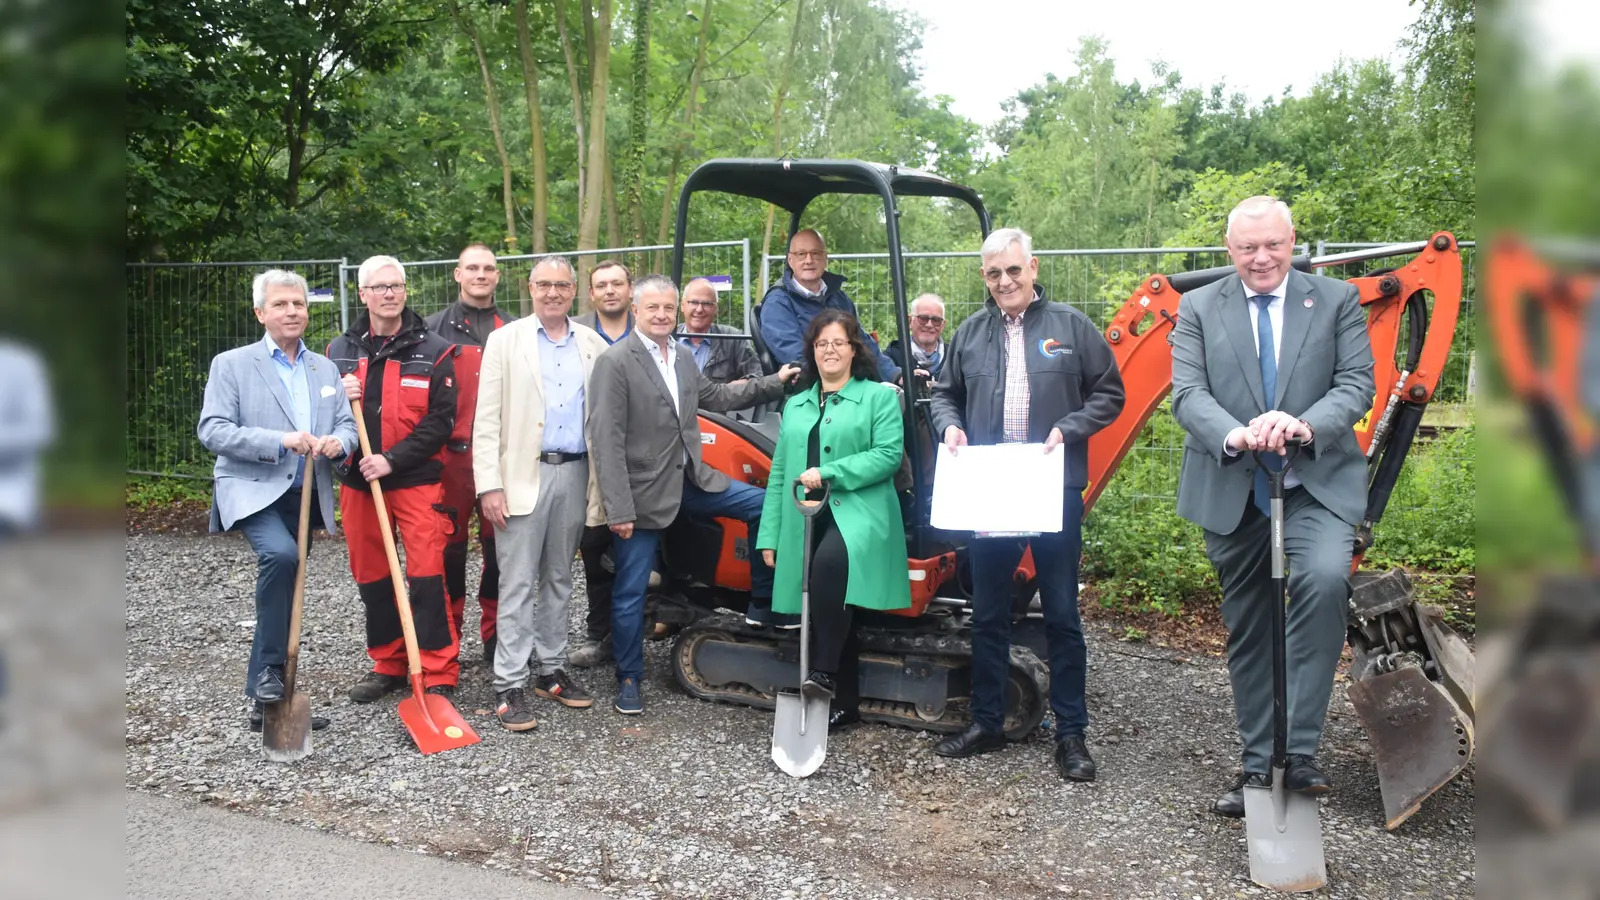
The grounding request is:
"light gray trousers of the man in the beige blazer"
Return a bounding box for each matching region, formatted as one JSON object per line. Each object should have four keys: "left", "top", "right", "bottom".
{"left": 494, "top": 460, "right": 589, "bottom": 690}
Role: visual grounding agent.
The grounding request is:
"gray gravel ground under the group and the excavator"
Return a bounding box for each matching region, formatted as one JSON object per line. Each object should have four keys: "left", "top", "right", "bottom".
{"left": 125, "top": 535, "right": 1475, "bottom": 900}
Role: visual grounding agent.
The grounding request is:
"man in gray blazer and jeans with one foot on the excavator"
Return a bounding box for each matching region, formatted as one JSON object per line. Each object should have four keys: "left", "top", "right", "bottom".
{"left": 589, "top": 275, "right": 800, "bottom": 716}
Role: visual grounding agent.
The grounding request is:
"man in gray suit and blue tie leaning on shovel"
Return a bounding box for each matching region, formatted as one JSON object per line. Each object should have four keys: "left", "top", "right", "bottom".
{"left": 1171, "top": 197, "right": 1373, "bottom": 818}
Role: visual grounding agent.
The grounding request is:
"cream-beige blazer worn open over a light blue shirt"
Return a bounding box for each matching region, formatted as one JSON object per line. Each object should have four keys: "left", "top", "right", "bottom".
{"left": 472, "top": 319, "right": 606, "bottom": 525}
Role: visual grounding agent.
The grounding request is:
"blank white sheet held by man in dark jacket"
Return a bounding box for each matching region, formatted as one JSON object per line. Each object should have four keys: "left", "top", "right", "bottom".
{"left": 930, "top": 444, "right": 1067, "bottom": 533}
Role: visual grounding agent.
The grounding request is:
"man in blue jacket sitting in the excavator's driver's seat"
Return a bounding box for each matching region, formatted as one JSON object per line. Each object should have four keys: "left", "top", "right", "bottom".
{"left": 760, "top": 229, "right": 899, "bottom": 384}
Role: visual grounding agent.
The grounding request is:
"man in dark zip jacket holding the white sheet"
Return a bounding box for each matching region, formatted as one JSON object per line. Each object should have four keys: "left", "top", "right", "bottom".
{"left": 933, "top": 227, "right": 1125, "bottom": 781}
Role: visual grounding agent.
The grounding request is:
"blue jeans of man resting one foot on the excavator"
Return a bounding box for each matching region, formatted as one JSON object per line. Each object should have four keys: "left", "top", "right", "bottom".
{"left": 611, "top": 479, "right": 773, "bottom": 681}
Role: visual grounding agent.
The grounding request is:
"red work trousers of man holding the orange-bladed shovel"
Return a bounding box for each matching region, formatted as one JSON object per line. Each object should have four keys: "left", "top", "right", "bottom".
{"left": 339, "top": 484, "right": 461, "bottom": 687}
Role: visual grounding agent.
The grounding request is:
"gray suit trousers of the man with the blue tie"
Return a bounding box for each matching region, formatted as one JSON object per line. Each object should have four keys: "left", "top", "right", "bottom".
{"left": 1205, "top": 490, "right": 1355, "bottom": 773}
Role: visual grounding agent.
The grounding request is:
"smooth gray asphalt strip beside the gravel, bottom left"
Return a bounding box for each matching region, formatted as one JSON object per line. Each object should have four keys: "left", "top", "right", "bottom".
{"left": 126, "top": 791, "right": 602, "bottom": 900}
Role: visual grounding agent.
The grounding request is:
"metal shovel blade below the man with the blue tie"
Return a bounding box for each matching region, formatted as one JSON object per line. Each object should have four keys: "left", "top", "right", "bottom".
{"left": 1245, "top": 767, "right": 1328, "bottom": 894}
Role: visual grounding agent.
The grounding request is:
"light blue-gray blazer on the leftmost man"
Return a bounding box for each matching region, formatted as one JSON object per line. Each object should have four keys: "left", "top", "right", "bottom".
{"left": 197, "top": 341, "right": 357, "bottom": 532}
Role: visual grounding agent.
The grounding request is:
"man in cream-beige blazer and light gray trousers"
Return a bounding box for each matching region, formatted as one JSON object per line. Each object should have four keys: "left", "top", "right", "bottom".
{"left": 472, "top": 256, "right": 606, "bottom": 732}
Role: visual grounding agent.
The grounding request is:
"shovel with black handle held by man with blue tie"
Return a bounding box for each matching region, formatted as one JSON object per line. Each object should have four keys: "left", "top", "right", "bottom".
{"left": 1243, "top": 442, "right": 1328, "bottom": 892}
